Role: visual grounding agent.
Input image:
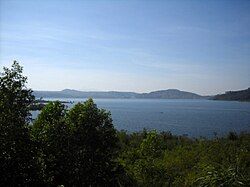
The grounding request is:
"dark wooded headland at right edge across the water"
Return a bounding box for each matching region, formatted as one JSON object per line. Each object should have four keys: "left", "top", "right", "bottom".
{"left": 213, "top": 88, "right": 250, "bottom": 101}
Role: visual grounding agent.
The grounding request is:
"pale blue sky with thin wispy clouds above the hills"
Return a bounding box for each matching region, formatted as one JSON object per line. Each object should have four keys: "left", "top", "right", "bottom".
{"left": 0, "top": 0, "right": 250, "bottom": 95}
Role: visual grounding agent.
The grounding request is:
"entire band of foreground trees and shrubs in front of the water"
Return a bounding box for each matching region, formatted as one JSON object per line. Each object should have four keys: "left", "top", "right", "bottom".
{"left": 0, "top": 62, "right": 250, "bottom": 186}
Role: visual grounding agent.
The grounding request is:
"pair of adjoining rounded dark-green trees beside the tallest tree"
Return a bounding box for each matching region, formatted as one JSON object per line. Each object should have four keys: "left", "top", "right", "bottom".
{"left": 32, "top": 99, "right": 119, "bottom": 186}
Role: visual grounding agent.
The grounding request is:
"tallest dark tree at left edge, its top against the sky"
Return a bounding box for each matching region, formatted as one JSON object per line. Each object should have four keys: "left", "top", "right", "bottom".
{"left": 0, "top": 61, "right": 37, "bottom": 186}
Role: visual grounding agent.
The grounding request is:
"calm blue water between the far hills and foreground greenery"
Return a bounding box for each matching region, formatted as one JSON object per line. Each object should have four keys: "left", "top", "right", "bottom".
{"left": 33, "top": 98, "right": 250, "bottom": 137}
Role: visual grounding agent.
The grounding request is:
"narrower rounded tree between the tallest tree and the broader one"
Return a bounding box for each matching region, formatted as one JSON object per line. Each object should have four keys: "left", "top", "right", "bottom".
{"left": 32, "top": 101, "right": 71, "bottom": 186}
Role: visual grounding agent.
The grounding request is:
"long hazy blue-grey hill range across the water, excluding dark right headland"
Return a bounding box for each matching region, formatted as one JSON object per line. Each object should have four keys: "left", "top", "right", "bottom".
{"left": 34, "top": 89, "right": 207, "bottom": 99}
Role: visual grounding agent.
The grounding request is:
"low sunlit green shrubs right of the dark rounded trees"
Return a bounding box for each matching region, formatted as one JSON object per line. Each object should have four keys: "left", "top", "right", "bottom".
{"left": 119, "top": 131, "right": 250, "bottom": 186}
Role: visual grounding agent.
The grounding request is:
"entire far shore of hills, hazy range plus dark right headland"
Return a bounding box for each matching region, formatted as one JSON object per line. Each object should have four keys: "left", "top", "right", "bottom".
{"left": 33, "top": 88, "right": 250, "bottom": 102}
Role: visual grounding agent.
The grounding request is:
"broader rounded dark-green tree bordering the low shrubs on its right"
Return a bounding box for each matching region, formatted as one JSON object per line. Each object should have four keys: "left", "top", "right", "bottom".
{"left": 67, "top": 99, "right": 118, "bottom": 186}
